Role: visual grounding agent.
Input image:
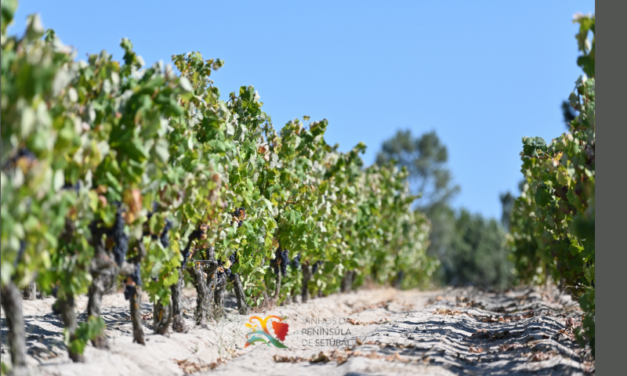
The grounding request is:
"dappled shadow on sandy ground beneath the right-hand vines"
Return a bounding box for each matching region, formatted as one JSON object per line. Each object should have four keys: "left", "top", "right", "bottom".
{"left": 352, "top": 289, "right": 593, "bottom": 376}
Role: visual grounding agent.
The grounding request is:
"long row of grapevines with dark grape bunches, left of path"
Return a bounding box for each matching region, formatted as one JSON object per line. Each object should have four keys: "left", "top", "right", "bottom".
{"left": 0, "top": 0, "right": 435, "bottom": 367}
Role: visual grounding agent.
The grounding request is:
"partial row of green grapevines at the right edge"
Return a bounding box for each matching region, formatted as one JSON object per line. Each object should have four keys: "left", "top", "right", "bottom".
{"left": 508, "top": 12, "right": 596, "bottom": 357}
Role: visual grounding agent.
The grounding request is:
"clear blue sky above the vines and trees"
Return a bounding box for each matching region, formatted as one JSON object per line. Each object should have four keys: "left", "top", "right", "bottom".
{"left": 11, "top": 0, "right": 595, "bottom": 218}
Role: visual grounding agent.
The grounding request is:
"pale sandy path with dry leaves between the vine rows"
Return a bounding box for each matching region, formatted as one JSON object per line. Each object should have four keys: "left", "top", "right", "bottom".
{"left": 2, "top": 289, "right": 594, "bottom": 376}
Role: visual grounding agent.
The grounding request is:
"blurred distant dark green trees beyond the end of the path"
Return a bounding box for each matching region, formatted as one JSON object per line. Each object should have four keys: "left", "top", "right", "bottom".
{"left": 377, "top": 130, "right": 514, "bottom": 288}
